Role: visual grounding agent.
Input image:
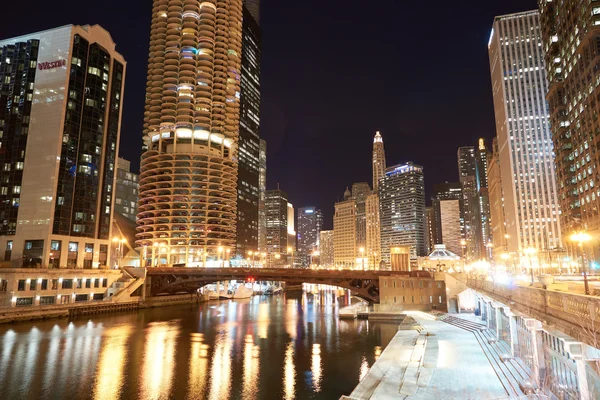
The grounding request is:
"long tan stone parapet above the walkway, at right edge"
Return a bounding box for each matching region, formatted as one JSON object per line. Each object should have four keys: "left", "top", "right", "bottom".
{"left": 464, "top": 277, "right": 600, "bottom": 346}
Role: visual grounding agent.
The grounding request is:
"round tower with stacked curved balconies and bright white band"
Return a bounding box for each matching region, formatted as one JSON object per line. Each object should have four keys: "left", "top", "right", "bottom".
{"left": 136, "top": 0, "right": 242, "bottom": 266}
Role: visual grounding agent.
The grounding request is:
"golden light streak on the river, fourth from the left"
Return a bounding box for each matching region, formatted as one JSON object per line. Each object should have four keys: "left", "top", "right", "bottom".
{"left": 209, "top": 331, "right": 233, "bottom": 400}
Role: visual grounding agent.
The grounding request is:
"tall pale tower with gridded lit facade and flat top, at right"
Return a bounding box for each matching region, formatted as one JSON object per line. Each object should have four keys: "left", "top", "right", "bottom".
{"left": 489, "top": 11, "right": 564, "bottom": 255}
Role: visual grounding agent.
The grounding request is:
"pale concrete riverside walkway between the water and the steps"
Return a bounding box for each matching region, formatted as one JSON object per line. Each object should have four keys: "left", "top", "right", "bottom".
{"left": 348, "top": 312, "right": 508, "bottom": 400}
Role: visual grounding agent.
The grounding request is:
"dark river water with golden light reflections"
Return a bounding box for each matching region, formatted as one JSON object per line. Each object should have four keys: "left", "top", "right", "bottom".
{"left": 0, "top": 291, "right": 398, "bottom": 400}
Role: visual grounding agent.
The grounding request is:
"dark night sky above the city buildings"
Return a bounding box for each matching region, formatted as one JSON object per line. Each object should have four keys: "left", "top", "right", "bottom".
{"left": 0, "top": 0, "right": 537, "bottom": 228}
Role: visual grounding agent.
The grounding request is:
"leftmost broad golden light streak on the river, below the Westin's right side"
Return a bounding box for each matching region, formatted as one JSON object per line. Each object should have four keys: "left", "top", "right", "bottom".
{"left": 94, "top": 325, "right": 131, "bottom": 400}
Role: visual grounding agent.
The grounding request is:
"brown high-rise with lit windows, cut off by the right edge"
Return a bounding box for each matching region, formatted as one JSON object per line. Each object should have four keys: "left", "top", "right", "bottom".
{"left": 538, "top": 0, "right": 600, "bottom": 236}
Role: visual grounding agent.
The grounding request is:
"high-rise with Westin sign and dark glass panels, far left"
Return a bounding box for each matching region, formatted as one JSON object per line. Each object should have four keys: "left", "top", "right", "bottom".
{"left": 0, "top": 25, "right": 125, "bottom": 268}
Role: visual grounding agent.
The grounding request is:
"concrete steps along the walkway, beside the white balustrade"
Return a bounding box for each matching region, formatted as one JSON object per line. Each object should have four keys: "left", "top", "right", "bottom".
{"left": 438, "top": 315, "right": 538, "bottom": 398}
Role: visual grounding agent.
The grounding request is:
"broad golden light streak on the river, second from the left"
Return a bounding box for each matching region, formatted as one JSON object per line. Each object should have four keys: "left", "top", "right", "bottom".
{"left": 141, "top": 321, "right": 179, "bottom": 399}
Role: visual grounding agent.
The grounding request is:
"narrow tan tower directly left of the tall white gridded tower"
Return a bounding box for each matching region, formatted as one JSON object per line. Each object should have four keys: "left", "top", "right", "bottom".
{"left": 488, "top": 138, "right": 508, "bottom": 262}
